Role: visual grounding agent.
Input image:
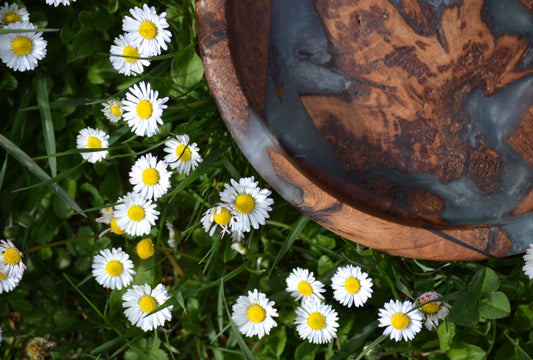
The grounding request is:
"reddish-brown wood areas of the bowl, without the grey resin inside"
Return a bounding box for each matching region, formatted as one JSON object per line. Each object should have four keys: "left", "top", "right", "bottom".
{"left": 197, "top": 0, "right": 533, "bottom": 260}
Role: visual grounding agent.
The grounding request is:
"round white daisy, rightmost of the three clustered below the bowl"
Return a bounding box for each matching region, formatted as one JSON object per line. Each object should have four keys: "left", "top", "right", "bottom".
{"left": 331, "top": 265, "right": 372, "bottom": 307}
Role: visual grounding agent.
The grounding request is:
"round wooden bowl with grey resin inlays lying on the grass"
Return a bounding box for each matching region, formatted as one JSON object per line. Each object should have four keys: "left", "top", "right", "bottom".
{"left": 197, "top": 0, "right": 533, "bottom": 260}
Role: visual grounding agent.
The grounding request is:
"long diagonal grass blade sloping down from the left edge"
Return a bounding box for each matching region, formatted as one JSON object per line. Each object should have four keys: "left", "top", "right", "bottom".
{"left": 0, "top": 134, "right": 87, "bottom": 217}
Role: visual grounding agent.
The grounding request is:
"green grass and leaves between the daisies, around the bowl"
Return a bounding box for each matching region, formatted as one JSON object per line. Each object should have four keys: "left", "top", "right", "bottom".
{"left": 0, "top": 0, "right": 533, "bottom": 360}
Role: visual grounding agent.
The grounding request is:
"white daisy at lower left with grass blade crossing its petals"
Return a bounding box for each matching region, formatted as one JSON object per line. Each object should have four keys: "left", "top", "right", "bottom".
{"left": 122, "top": 284, "right": 172, "bottom": 331}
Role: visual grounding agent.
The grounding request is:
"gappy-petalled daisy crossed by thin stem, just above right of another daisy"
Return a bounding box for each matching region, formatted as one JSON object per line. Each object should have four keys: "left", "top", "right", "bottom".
{"left": 165, "top": 135, "right": 202, "bottom": 175}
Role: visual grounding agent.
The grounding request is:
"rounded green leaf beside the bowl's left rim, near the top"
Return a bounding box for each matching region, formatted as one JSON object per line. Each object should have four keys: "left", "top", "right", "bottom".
{"left": 171, "top": 48, "right": 204, "bottom": 89}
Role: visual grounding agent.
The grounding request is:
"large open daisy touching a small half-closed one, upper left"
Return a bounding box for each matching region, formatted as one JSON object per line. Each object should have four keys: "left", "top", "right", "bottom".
{"left": 122, "top": 81, "right": 168, "bottom": 137}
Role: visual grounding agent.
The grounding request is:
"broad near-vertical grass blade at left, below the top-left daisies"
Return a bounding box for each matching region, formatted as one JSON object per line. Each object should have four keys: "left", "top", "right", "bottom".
{"left": 35, "top": 73, "right": 57, "bottom": 176}
